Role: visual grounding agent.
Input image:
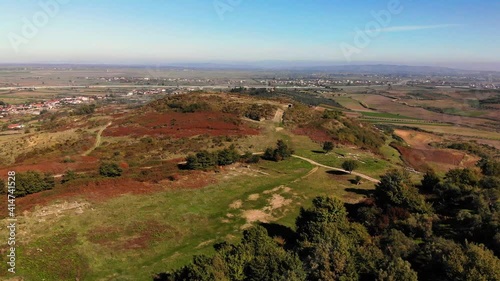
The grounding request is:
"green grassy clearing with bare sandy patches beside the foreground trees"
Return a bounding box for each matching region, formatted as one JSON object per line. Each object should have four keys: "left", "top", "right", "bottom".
{"left": 0, "top": 154, "right": 373, "bottom": 281}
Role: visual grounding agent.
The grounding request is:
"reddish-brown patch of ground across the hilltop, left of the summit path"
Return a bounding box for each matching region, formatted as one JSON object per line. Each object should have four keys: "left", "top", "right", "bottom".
{"left": 103, "top": 112, "right": 259, "bottom": 138}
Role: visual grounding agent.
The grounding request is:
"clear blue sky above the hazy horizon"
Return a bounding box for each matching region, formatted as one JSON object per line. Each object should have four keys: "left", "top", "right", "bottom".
{"left": 0, "top": 0, "right": 500, "bottom": 70}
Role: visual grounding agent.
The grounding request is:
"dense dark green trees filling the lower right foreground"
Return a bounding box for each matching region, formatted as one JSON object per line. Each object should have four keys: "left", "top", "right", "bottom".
{"left": 155, "top": 160, "right": 500, "bottom": 281}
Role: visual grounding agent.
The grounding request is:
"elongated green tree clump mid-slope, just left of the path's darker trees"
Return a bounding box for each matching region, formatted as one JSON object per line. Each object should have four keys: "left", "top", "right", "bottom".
{"left": 186, "top": 145, "right": 241, "bottom": 170}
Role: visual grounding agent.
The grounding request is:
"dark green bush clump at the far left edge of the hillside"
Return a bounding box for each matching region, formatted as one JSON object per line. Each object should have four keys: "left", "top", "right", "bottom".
{"left": 0, "top": 171, "right": 55, "bottom": 197}
